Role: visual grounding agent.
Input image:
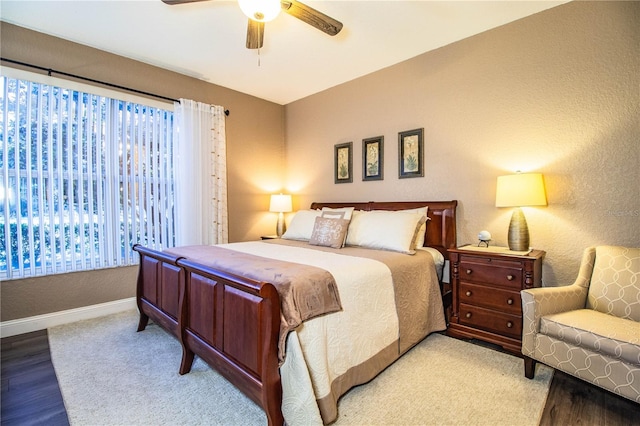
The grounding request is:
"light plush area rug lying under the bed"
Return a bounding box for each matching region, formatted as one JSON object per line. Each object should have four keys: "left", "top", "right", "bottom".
{"left": 49, "top": 311, "right": 552, "bottom": 426}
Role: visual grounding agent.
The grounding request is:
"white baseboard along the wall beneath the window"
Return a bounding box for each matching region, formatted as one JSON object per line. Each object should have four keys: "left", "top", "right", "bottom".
{"left": 0, "top": 297, "right": 136, "bottom": 337}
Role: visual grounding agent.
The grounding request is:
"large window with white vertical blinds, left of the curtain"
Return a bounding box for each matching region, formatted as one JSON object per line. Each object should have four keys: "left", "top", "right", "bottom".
{"left": 0, "top": 68, "right": 175, "bottom": 279}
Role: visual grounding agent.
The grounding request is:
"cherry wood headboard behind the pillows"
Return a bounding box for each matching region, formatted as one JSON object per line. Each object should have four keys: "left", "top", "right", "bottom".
{"left": 311, "top": 200, "right": 458, "bottom": 259}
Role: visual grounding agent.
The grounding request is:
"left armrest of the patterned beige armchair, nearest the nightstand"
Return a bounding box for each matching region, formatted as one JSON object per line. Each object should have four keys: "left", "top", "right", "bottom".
{"left": 520, "top": 284, "right": 588, "bottom": 358}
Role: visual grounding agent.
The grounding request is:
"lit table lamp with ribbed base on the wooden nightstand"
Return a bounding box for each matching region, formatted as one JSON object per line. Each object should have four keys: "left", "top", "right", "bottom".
{"left": 496, "top": 173, "right": 547, "bottom": 251}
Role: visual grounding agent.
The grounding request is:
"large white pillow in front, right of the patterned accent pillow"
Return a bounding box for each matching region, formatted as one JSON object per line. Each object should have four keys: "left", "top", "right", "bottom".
{"left": 347, "top": 210, "right": 425, "bottom": 254}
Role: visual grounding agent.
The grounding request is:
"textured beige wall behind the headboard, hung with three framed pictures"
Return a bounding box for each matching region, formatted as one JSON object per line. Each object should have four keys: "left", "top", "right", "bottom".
{"left": 286, "top": 2, "right": 640, "bottom": 285}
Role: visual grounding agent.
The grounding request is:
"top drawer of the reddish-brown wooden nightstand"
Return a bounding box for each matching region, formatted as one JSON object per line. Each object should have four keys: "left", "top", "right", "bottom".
{"left": 460, "top": 256, "right": 522, "bottom": 289}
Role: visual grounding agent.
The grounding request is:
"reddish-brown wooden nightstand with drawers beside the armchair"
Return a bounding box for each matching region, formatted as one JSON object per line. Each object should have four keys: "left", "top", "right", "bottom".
{"left": 447, "top": 246, "right": 545, "bottom": 356}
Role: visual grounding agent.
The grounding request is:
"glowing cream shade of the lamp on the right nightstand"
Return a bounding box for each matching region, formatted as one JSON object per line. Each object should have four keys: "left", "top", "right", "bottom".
{"left": 496, "top": 173, "right": 547, "bottom": 207}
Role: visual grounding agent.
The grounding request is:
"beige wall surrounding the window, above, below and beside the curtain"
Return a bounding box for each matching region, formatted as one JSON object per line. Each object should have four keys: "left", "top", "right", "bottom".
{"left": 0, "top": 22, "right": 284, "bottom": 321}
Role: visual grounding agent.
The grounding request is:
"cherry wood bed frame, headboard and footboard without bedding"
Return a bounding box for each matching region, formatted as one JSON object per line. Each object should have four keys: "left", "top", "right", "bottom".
{"left": 134, "top": 200, "right": 457, "bottom": 425}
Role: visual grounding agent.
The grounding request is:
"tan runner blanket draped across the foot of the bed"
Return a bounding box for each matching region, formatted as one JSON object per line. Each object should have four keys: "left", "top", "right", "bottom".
{"left": 164, "top": 245, "right": 342, "bottom": 362}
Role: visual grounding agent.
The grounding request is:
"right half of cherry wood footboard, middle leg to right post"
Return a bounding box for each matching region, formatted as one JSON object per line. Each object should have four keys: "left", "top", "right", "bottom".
{"left": 178, "top": 259, "right": 284, "bottom": 425}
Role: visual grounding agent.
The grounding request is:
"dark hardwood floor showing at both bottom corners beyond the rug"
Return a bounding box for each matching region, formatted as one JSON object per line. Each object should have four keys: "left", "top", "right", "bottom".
{"left": 1, "top": 330, "right": 640, "bottom": 426}
